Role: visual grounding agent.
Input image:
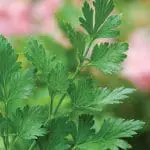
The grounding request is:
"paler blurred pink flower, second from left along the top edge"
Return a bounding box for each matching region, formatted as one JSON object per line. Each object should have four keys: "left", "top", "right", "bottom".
{"left": 32, "top": 0, "right": 62, "bottom": 34}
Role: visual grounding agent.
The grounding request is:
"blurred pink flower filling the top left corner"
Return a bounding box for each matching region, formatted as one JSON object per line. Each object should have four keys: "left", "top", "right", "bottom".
{"left": 0, "top": 0, "right": 31, "bottom": 35}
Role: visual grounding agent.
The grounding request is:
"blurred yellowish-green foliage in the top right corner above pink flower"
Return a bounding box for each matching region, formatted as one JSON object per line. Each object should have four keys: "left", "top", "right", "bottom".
{"left": 114, "top": 0, "right": 150, "bottom": 39}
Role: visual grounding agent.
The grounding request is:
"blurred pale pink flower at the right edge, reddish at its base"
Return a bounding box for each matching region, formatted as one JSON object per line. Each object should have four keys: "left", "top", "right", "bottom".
{"left": 122, "top": 29, "right": 150, "bottom": 91}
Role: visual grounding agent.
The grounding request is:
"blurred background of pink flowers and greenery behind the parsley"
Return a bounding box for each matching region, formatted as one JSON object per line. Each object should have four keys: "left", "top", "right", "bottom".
{"left": 0, "top": 0, "right": 150, "bottom": 150}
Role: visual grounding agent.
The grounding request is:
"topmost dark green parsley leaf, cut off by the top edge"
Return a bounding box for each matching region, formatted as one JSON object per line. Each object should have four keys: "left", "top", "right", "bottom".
{"left": 79, "top": 0, "right": 115, "bottom": 38}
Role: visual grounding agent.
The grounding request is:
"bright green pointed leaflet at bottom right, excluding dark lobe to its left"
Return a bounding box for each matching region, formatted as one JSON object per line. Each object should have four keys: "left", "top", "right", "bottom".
{"left": 83, "top": 119, "right": 144, "bottom": 150}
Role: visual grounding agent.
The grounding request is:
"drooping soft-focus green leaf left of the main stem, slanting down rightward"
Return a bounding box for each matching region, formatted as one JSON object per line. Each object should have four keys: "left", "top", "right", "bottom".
{"left": 26, "top": 39, "right": 68, "bottom": 94}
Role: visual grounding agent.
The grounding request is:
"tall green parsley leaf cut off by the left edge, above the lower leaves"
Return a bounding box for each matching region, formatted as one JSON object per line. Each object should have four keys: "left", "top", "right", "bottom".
{"left": 0, "top": 36, "right": 33, "bottom": 102}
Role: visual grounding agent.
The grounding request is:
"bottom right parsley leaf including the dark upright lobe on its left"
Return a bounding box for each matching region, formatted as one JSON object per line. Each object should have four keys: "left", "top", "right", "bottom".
{"left": 75, "top": 116, "right": 144, "bottom": 150}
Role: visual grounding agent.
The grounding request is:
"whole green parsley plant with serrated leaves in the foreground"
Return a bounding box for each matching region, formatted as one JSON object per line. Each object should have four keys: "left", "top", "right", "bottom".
{"left": 0, "top": 0, "right": 144, "bottom": 150}
